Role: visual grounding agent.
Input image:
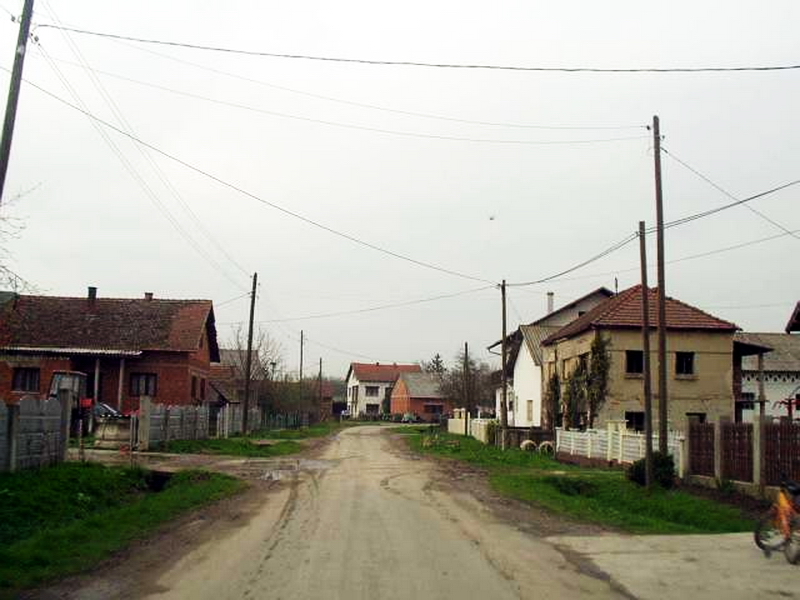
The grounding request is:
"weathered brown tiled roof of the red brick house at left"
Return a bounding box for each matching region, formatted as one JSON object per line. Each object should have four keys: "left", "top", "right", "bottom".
{"left": 0, "top": 296, "right": 219, "bottom": 362}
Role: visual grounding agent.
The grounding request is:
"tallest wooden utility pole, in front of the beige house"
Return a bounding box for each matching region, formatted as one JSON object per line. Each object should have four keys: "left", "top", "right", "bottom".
{"left": 653, "top": 116, "right": 668, "bottom": 455}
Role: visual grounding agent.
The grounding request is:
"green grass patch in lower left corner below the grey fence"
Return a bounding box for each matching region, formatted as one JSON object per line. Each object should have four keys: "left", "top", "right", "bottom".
{"left": 0, "top": 463, "right": 246, "bottom": 598}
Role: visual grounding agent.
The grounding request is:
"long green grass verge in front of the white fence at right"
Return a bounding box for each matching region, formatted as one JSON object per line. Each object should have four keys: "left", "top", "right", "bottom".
{"left": 409, "top": 434, "right": 754, "bottom": 534}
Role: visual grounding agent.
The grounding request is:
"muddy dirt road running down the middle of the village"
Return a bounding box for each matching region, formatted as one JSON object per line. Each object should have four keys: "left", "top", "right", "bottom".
{"left": 47, "top": 427, "right": 629, "bottom": 600}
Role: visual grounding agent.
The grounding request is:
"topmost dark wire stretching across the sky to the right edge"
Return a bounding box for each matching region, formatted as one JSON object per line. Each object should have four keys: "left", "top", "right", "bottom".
{"left": 32, "top": 23, "right": 800, "bottom": 73}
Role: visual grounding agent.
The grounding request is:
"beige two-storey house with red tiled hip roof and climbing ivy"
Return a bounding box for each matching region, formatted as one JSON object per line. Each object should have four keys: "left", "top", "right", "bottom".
{"left": 542, "top": 285, "right": 740, "bottom": 430}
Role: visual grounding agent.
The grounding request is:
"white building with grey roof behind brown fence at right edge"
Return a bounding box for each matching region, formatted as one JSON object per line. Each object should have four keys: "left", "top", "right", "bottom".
{"left": 734, "top": 332, "right": 800, "bottom": 422}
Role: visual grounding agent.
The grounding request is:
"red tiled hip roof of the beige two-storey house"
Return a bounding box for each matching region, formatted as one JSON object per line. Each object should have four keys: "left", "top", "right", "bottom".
{"left": 542, "top": 285, "right": 739, "bottom": 346}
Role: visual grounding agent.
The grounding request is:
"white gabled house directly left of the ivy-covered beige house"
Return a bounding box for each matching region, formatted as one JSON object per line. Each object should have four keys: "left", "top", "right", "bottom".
{"left": 489, "top": 287, "right": 614, "bottom": 427}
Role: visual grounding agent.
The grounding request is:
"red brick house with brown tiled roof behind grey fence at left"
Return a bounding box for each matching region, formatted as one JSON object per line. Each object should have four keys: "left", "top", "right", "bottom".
{"left": 0, "top": 287, "right": 219, "bottom": 412}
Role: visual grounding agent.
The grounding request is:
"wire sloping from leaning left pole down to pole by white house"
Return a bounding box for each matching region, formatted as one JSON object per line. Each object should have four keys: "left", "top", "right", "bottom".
{"left": 12, "top": 67, "right": 494, "bottom": 285}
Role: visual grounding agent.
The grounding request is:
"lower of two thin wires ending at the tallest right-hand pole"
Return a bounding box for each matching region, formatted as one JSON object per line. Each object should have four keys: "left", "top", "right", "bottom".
{"left": 25, "top": 53, "right": 648, "bottom": 146}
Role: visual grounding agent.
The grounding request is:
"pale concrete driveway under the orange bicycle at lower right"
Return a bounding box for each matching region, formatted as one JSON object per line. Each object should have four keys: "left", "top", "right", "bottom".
{"left": 547, "top": 533, "right": 800, "bottom": 600}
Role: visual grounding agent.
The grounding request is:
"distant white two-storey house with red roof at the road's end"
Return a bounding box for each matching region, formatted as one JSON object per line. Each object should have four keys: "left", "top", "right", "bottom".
{"left": 345, "top": 363, "right": 422, "bottom": 416}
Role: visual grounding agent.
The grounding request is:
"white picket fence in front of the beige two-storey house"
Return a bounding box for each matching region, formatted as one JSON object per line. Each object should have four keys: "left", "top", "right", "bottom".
{"left": 556, "top": 428, "right": 688, "bottom": 477}
